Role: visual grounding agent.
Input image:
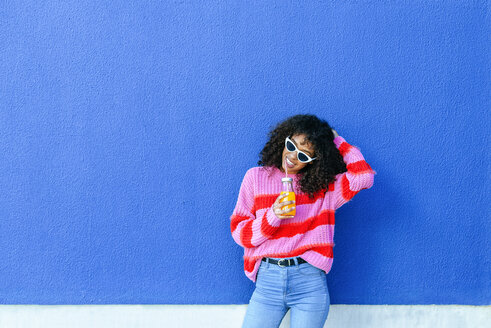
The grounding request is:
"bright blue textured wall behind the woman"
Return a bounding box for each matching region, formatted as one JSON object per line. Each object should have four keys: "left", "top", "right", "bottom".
{"left": 0, "top": 0, "right": 491, "bottom": 304}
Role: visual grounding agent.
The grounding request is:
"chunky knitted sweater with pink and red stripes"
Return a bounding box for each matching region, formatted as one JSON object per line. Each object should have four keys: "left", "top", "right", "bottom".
{"left": 230, "top": 136, "right": 376, "bottom": 282}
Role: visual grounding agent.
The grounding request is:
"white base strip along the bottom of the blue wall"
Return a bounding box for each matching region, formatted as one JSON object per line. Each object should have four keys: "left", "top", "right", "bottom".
{"left": 0, "top": 304, "right": 491, "bottom": 328}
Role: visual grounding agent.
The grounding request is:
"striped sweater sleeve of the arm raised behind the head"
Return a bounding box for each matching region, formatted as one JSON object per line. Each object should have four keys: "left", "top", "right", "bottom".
{"left": 334, "top": 136, "right": 376, "bottom": 210}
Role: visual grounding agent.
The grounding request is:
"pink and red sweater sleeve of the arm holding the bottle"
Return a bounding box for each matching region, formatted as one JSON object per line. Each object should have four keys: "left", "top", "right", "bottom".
{"left": 230, "top": 169, "right": 281, "bottom": 248}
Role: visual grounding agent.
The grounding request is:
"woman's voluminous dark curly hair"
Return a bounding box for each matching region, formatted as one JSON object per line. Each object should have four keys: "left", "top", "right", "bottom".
{"left": 258, "top": 115, "right": 347, "bottom": 198}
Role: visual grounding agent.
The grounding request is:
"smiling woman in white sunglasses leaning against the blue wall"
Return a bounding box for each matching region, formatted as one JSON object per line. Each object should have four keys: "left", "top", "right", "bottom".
{"left": 230, "top": 115, "right": 375, "bottom": 328}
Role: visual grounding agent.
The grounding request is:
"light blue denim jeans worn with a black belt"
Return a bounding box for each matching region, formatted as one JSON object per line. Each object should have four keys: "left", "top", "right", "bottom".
{"left": 242, "top": 261, "right": 330, "bottom": 328}
